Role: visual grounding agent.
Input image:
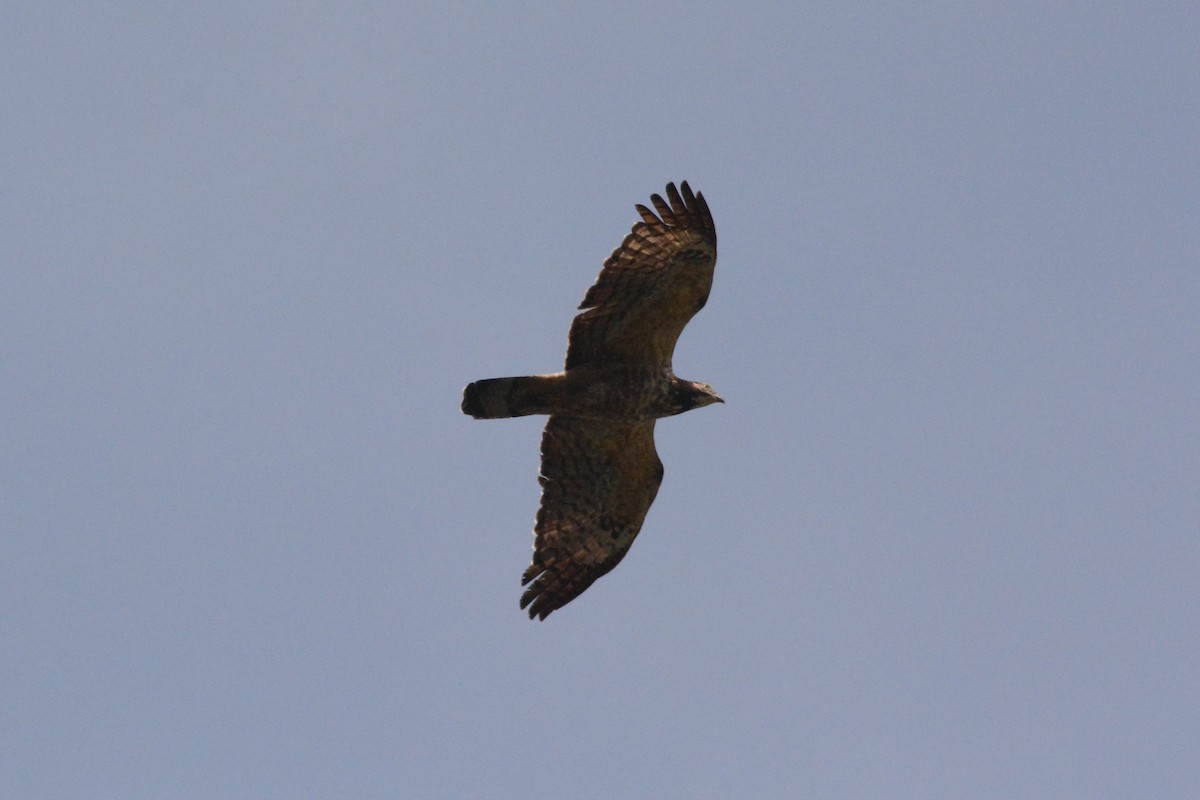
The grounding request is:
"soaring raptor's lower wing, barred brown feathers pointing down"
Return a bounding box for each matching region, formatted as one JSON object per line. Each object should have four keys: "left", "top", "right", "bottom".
{"left": 521, "top": 416, "right": 662, "bottom": 619}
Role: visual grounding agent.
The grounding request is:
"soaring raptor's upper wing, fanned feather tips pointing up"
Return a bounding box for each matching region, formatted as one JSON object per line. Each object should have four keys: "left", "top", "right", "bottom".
{"left": 566, "top": 181, "right": 716, "bottom": 369}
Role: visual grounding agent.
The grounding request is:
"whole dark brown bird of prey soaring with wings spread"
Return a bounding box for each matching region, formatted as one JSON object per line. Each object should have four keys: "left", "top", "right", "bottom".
{"left": 462, "top": 182, "right": 724, "bottom": 619}
